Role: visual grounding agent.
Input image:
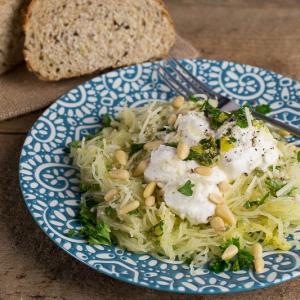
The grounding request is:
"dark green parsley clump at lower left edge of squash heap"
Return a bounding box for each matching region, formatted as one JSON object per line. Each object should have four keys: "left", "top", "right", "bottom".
{"left": 67, "top": 200, "right": 112, "bottom": 245}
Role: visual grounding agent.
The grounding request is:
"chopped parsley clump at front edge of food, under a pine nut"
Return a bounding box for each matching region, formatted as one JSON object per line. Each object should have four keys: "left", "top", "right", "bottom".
{"left": 209, "top": 238, "right": 254, "bottom": 273}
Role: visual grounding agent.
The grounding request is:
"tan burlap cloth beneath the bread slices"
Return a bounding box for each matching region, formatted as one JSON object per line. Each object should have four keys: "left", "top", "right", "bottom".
{"left": 0, "top": 35, "right": 199, "bottom": 121}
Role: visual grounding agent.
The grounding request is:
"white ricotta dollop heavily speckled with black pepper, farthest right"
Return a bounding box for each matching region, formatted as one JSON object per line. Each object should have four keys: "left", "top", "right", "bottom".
{"left": 217, "top": 123, "right": 280, "bottom": 180}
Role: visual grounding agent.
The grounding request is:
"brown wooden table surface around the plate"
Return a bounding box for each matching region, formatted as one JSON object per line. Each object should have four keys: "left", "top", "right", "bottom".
{"left": 0, "top": 0, "right": 300, "bottom": 300}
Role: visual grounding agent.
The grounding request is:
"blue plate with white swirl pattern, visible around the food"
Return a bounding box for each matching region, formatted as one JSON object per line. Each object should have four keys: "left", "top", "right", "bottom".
{"left": 20, "top": 60, "right": 300, "bottom": 294}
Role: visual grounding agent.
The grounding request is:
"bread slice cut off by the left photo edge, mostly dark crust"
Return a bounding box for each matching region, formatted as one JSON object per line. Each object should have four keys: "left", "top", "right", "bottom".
{"left": 0, "top": 0, "right": 26, "bottom": 74}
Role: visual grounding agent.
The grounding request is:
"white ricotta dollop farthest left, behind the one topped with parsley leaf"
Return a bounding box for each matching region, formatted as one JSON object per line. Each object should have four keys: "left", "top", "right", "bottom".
{"left": 144, "top": 145, "right": 198, "bottom": 183}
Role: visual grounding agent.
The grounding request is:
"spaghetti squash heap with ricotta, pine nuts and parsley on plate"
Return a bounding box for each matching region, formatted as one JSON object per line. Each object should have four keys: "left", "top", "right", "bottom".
{"left": 69, "top": 96, "right": 300, "bottom": 272}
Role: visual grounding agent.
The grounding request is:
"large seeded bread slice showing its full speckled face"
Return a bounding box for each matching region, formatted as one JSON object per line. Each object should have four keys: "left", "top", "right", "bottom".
{"left": 24, "top": 0, "right": 175, "bottom": 81}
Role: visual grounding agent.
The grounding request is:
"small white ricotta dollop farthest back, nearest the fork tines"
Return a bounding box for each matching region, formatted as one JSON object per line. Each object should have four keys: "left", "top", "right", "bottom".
{"left": 175, "top": 111, "right": 214, "bottom": 146}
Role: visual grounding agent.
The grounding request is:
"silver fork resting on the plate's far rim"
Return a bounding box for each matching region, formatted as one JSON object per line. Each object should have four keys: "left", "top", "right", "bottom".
{"left": 159, "top": 58, "right": 300, "bottom": 137}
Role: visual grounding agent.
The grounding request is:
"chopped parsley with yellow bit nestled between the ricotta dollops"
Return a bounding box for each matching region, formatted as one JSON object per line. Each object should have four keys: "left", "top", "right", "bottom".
{"left": 187, "top": 137, "right": 219, "bottom": 166}
